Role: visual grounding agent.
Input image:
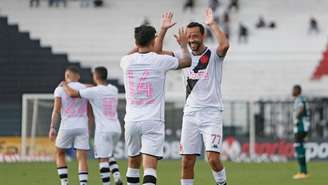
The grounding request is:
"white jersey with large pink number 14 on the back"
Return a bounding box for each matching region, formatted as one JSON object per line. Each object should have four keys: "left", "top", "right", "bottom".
{"left": 121, "top": 52, "right": 179, "bottom": 121}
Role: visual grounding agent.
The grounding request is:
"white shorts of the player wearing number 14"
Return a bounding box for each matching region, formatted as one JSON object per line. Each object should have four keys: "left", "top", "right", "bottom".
{"left": 124, "top": 121, "right": 165, "bottom": 159}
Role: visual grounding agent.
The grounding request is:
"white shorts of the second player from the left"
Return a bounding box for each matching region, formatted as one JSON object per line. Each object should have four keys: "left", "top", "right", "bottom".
{"left": 94, "top": 132, "right": 121, "bottom": 159}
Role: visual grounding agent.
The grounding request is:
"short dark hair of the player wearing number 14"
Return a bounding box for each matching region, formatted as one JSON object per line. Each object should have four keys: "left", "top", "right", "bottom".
{"left": 134, "top": 25, "right": 156, "bottom": 47}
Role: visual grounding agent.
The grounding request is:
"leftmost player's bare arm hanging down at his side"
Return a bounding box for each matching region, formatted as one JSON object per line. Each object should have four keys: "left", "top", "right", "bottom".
{"left": 49, "top": 97, "right": 62, "bottom": 142}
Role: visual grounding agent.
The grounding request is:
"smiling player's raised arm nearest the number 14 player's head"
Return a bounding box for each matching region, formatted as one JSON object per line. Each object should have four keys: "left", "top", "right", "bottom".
{"left": 155, "top": 12, "right": 176, "bottom": 56}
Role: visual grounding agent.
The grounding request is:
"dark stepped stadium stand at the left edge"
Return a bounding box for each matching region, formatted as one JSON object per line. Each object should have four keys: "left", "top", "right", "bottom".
{"left": 0, "top": 14, "right": 91, "bottom": 135}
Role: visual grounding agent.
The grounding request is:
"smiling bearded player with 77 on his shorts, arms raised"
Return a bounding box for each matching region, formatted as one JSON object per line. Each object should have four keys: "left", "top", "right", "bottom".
{"left": 156, "top": 9, "right": 229, "bottom": 185}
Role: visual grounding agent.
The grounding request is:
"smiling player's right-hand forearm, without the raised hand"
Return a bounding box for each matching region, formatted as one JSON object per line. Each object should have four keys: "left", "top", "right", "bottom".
{"left": 209, "top": 22, "right": 229, "bottom": 55}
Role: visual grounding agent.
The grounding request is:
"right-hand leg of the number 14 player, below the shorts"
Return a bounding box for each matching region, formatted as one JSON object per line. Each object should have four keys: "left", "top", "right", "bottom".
{"left": 142, "top": 154, "right": 158, "bottom": 185}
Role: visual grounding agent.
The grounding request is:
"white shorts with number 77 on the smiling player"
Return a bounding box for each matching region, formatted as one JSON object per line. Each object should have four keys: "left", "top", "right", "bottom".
{"left": 180, "top": 109, "right": 223, "bottom": 155}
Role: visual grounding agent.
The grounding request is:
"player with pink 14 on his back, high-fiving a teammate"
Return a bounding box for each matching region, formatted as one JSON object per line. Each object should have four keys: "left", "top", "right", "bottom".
{"left": 121, "top": 13, "right": 191, "bottom": 185}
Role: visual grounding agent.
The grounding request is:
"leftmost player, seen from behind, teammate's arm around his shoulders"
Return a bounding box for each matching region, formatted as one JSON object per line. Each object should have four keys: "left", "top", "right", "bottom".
{"left": 49, "top": 67, "right": 89, "bottom": 185}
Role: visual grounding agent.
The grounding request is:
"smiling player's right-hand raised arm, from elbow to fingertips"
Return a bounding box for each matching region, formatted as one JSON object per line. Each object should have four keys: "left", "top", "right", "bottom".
{"left": 205, "top": 8, "right": 229, "bottom": 57}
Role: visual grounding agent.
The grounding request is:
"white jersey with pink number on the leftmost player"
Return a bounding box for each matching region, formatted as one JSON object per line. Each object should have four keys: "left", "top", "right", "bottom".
{"left": 54, "top": 82, "right": 88, "bottom": 129}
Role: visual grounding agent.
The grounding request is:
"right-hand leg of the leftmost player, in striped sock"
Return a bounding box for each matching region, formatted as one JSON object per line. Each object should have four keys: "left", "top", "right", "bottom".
{"left": 76, "top": 150, "right": 88, "bottom": 185}
